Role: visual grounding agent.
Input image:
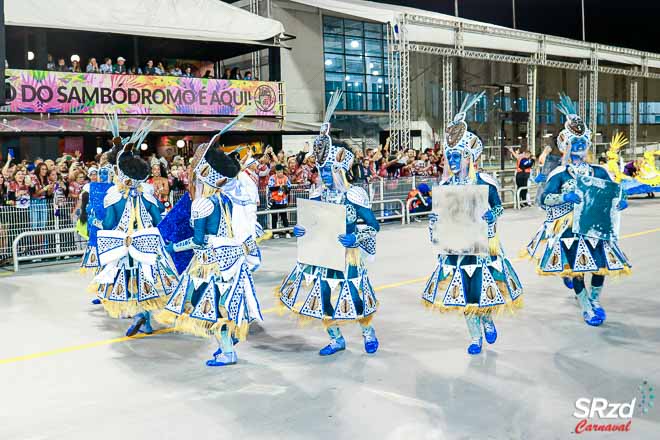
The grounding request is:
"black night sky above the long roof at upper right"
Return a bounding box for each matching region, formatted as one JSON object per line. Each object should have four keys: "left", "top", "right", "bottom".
{"left": 375, "top": 0, "right": 660, "bottom": 53}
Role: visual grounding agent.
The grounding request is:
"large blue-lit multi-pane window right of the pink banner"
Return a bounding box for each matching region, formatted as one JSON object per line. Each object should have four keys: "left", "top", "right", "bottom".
{"left": 323, "top": 16, "right": 389, "bottom": 112}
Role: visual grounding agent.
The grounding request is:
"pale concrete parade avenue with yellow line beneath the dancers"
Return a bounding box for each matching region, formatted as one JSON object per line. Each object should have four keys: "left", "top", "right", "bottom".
{"left": 0, "top": 198, "right": 660, "bottom": 440}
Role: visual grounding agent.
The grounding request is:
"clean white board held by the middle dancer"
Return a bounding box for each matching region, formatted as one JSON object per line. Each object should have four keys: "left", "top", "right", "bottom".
{"left": 297, "top": 199, "right": 346, "bottom": 272}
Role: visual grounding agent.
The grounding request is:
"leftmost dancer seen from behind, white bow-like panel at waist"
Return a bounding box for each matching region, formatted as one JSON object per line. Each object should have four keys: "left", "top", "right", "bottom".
{"left": 94, "top": 119, "right": 177, "bottom": 336}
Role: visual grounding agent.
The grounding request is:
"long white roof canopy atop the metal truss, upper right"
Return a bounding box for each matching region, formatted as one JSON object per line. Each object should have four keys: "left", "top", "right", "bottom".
{"left": 290, "top": 0, "right": 660, "bottom": 68}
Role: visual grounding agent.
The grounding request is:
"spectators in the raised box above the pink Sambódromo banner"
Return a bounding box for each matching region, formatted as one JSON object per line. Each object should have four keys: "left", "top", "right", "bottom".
{"left": 46, "top": 54, "right": 255, "bottom": 81}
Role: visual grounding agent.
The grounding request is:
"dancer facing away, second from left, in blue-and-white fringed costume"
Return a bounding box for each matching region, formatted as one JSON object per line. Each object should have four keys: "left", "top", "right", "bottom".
{"left": 156, "top": 117, "right": 263, "bottom": 367}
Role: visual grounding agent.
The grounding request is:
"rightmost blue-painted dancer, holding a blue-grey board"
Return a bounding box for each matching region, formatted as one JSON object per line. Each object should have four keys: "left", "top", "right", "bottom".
{"left": 537, "top": 94, "right": 631, "bottom": 326}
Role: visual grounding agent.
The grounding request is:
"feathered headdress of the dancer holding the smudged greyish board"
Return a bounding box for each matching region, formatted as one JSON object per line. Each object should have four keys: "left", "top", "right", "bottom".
{"left": 443, "top": 91, "right": 486, "bottom": 163}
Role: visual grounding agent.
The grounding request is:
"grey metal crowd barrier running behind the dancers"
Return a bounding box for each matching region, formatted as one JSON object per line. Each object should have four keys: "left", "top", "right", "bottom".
{"left": 5, "top": 171, "right": 520, "bottom": 267}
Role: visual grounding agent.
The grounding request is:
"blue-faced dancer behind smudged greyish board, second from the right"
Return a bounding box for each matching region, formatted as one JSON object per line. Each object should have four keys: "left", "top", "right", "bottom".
{"left": 422, "top": 92, "right": 522, "bottom": 354}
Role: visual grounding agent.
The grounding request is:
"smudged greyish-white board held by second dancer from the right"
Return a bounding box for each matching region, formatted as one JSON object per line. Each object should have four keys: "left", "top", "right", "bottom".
{"left": 433, "top": 185, "right": 489, "bottom": 256}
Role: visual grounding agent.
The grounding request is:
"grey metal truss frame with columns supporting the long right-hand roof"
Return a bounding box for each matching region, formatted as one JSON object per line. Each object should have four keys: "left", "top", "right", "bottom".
{"left": 388, "top": 14, "right": 660, "bottom": 151}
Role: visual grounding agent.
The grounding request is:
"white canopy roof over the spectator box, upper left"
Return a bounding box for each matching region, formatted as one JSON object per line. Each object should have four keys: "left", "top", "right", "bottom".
{"left": 5, "top": 0, "right": 284, "bottom": 44}
